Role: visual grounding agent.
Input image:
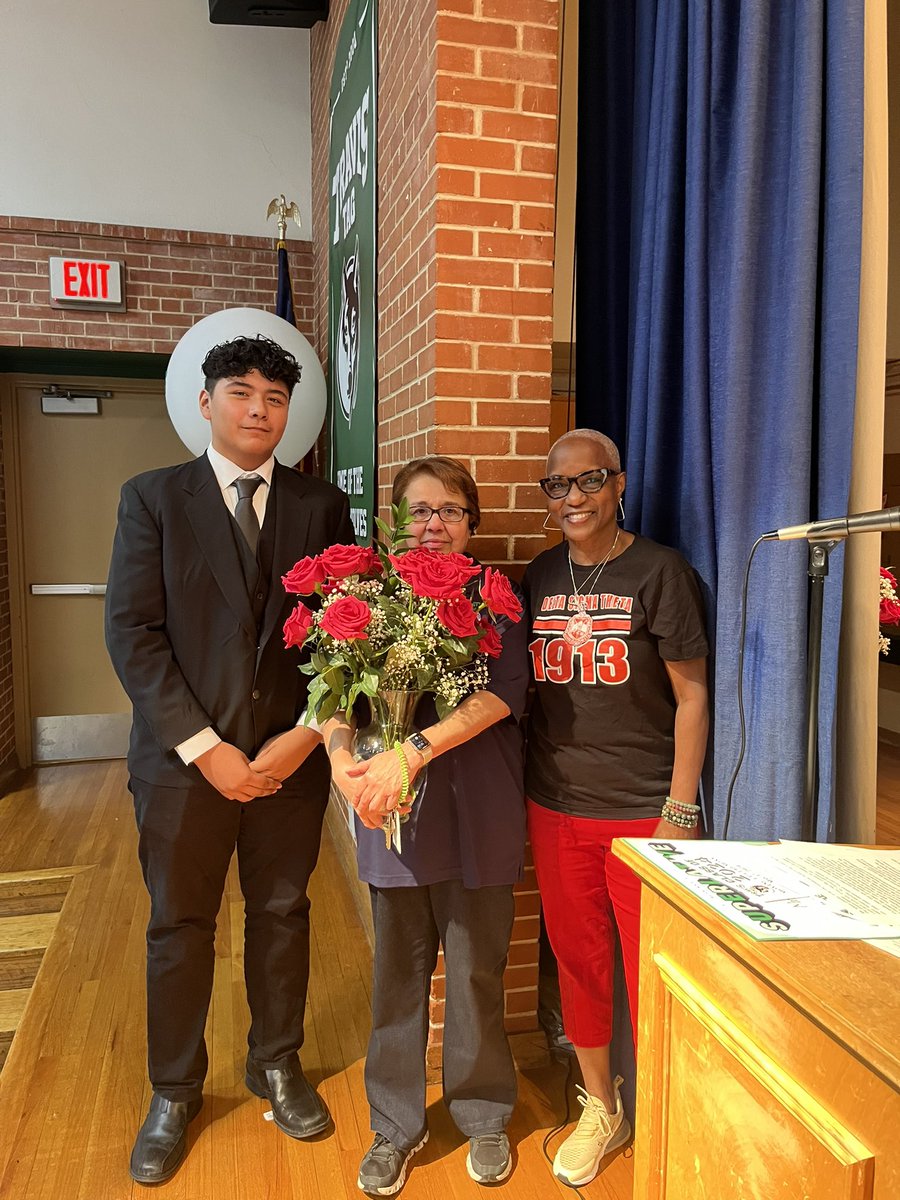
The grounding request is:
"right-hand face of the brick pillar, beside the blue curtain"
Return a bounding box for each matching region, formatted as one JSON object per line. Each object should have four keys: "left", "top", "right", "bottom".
{"left": 432, "top": 0, "right": 559, "bottom": 574}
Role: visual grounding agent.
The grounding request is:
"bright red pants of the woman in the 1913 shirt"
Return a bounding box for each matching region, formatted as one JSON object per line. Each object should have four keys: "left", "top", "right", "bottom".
{"left": 528, "top": 800, "right": 659, "bottom": 1048}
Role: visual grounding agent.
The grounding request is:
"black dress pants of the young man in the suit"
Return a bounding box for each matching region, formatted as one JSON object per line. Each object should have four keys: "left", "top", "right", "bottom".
{"left": 131, "top": 751, "right": 328, "bottom": 1100}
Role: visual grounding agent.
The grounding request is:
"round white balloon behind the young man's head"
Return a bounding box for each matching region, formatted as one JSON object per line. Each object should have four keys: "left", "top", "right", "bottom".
{"left": 166, "top": 308, "right": 326, "bottom": 467}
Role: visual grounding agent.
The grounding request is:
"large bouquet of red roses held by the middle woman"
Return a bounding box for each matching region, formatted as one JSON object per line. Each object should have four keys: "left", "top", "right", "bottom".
{"left": 282, "top": 500, "right": 522, "bottom": 721}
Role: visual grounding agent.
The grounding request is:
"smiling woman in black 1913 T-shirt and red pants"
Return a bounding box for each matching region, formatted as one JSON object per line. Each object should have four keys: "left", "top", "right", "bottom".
{"left": 522, "top": 430, "right": 708, "bottom": 1187}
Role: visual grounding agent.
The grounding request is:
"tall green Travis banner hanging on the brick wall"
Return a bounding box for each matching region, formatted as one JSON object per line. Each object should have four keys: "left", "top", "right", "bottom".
{"left": 328, "top": 0, "right": 376, "bottom": 545}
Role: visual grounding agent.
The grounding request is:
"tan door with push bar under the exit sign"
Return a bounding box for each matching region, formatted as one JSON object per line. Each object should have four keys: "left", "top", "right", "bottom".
{"left": 7, "top": 378, "right": 190, "bottom": 762}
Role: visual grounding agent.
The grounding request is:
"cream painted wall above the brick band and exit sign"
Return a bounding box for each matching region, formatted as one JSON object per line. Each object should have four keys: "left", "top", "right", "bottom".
{"left": 0, "top": 0, "right": 312, "bottom": 238}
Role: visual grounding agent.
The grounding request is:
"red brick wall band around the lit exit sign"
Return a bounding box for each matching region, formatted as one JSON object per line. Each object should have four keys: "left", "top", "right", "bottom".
{"left": 0, "top": 216, "right": 314, "bottom": 778}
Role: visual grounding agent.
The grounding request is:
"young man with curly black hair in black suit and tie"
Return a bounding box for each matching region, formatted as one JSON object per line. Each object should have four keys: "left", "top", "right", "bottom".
{"left": 106, "top": 337, "right": 354, "bottom": 1183}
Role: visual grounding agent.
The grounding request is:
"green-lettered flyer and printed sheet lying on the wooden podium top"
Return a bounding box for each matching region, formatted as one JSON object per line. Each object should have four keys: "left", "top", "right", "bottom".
{"left": 622, "top": 838, "right": 900, "bottom": 953}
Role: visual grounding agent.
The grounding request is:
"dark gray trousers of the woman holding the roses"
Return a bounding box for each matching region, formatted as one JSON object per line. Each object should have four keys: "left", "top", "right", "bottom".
{"left": 366, "top": 880, "right": 516, "bottom": 1150}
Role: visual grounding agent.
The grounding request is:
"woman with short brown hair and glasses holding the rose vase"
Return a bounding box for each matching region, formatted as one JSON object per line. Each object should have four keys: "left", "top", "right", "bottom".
{"left": 324, "top": 456, "right": 529, "bottom": 1195}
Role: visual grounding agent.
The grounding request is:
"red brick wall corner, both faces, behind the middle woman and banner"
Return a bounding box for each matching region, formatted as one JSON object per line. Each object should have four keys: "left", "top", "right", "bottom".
{"left": 311, "top": 0, "right": 558, "bottom": 1070}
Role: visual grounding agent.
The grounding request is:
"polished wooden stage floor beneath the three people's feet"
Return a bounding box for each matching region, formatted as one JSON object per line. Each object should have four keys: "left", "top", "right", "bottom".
{"left": 0, "top": 763, "right": 632, "bottom": 1200}
